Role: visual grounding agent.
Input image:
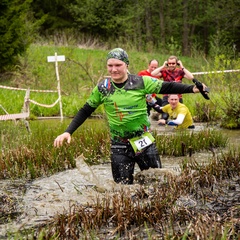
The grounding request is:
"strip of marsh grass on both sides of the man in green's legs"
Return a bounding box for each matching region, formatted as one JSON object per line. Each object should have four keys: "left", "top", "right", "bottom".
{"left": 0, "top": 119, "right": 227, "bottom": 179}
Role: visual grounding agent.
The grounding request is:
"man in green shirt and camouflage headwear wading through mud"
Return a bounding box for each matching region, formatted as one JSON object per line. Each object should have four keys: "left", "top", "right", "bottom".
{"left": 54, "top": 48, "right": 206, "bottom": 184}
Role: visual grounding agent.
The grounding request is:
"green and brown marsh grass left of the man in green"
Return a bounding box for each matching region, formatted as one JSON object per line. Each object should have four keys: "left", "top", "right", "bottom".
{"left": 0, "top": 120, "right": 109, "bottom": 179}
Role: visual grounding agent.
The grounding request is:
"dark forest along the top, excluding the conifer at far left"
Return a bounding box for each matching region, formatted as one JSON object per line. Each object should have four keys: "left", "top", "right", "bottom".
{"left": 19, "top": 0, "right": 240, "bottom": 57}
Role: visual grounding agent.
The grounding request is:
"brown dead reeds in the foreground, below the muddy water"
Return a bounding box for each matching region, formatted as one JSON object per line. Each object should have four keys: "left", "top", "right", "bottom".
{"left": 11, "top": 148, "right": 240, "bottom": 240}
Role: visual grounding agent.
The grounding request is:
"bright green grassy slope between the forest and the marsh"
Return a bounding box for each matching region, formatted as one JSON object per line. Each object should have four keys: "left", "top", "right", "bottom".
{"left": 0, "top": 44, "right": 240, "bottom": 126}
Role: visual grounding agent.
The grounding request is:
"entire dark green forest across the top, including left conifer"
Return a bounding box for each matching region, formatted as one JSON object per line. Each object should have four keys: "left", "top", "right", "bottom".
{"left": 0, "top": 0, "right": 240, "bottom": 72}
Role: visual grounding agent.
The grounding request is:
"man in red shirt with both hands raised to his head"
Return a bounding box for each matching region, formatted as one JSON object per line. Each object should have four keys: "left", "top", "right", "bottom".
{"left": 151, "top": 56, "right": 194, "bottom": 120}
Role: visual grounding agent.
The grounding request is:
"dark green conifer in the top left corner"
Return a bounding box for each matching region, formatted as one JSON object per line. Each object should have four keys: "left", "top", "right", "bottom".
{"left": 0, "top": 0, "right": 41, "bottom": 72}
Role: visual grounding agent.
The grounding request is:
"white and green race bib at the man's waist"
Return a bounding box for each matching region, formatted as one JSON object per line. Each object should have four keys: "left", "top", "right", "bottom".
{"left": 129, "top": 132, "right": 155, "bottom": 153}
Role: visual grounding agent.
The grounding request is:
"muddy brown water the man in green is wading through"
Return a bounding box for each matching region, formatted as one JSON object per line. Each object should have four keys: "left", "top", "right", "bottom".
{"left": 0, "top": 121, "right": 240, "bottom": 239}
